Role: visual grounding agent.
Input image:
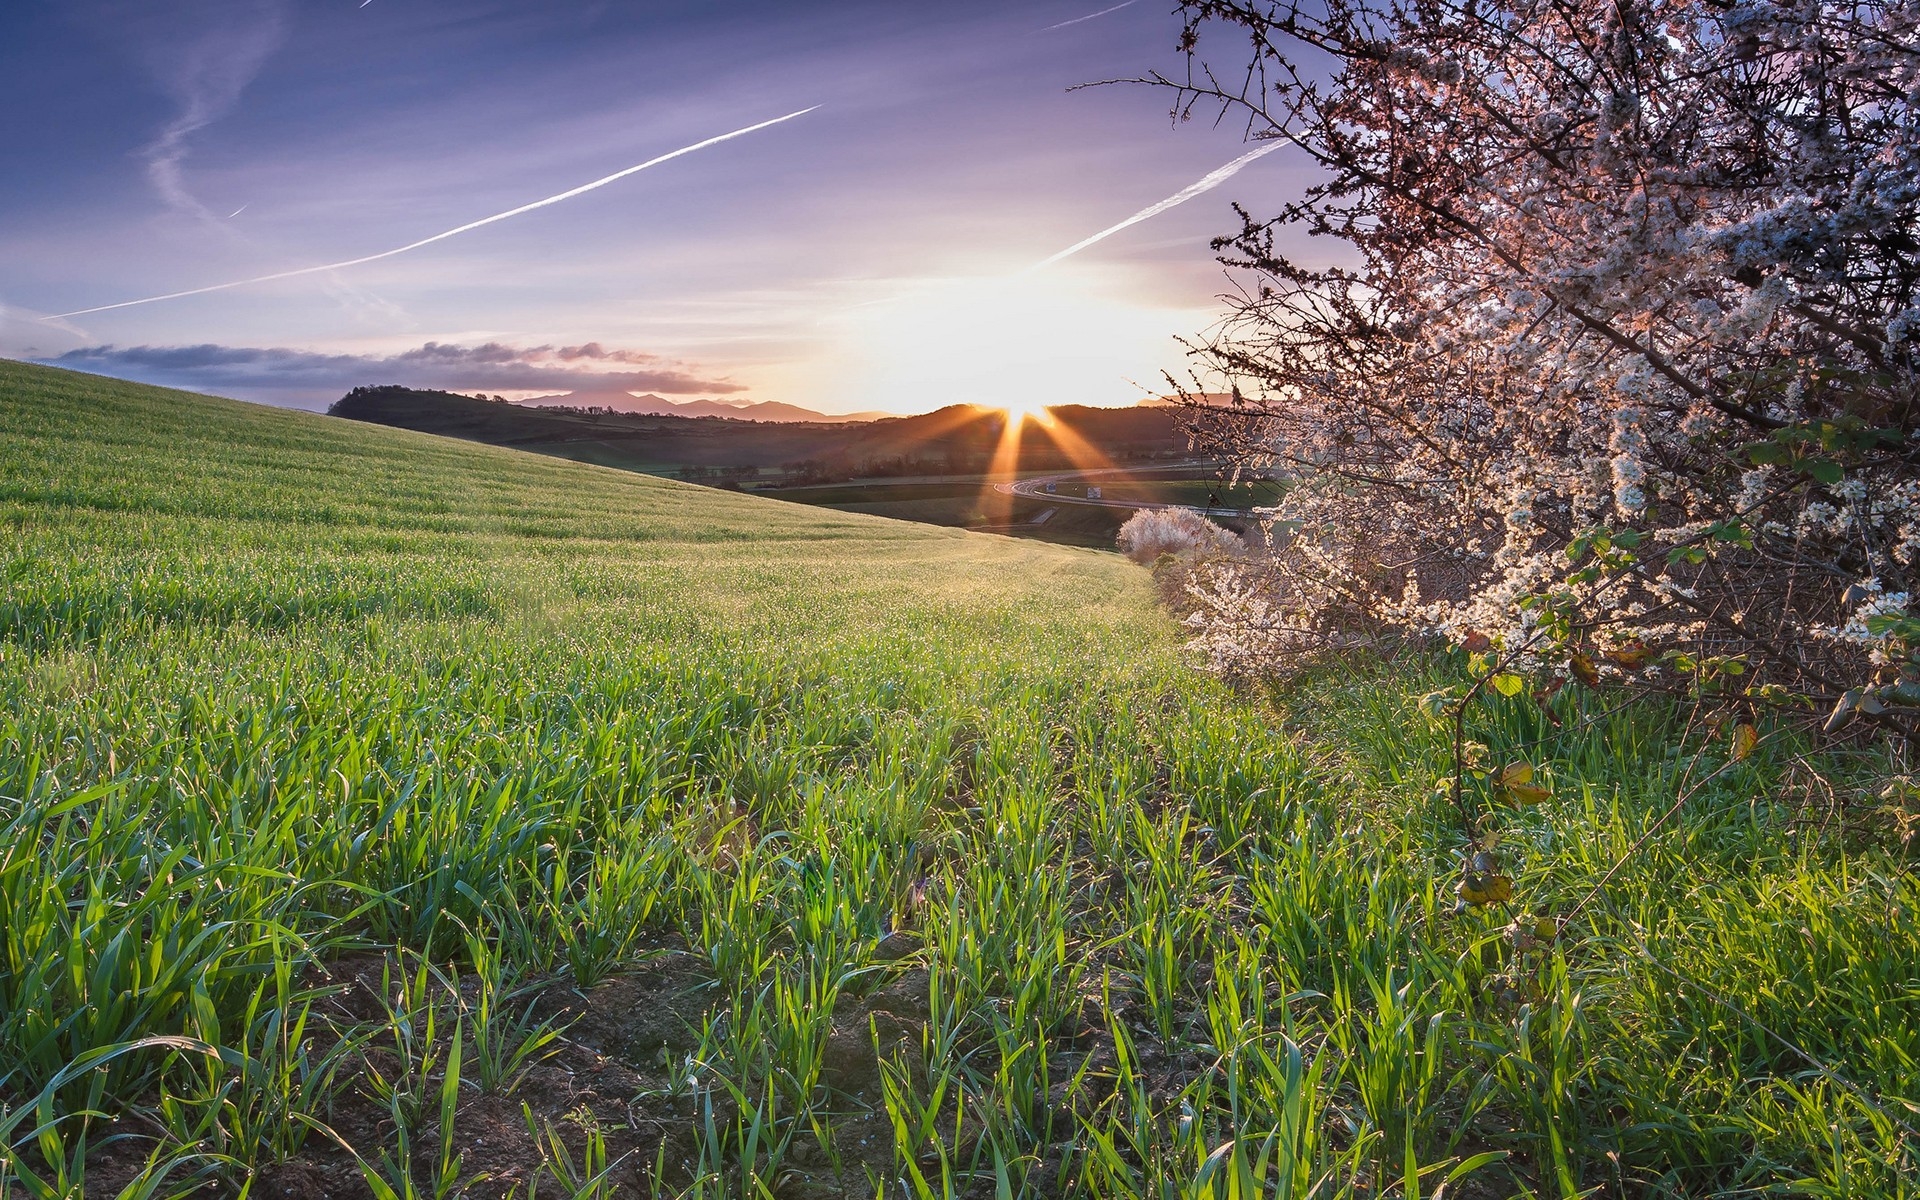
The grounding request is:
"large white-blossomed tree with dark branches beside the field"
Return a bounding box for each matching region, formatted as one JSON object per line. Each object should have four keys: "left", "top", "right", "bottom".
{"left": 1156, "top": 0, "right": 1920, "bottom": 724}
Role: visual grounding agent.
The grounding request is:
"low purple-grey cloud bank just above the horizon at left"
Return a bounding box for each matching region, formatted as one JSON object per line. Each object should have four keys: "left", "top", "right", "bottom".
{"left": 36, "top": 342, "right": 745, "bottom": 407}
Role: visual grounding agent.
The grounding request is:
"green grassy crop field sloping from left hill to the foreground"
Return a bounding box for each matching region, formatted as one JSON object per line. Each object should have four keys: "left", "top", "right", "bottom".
{"left": 0, "top": 363, "right": 1920, "bottom": 1200}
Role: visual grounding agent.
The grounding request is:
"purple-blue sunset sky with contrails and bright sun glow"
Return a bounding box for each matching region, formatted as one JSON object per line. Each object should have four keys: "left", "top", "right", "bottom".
{"left": 0, "top": 0, "right": 1309, "bottom": 413}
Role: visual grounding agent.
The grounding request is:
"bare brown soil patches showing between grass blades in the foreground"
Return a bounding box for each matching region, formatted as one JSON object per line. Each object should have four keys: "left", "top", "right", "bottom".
{"left": 88, "top": 935, "right": 1152, "bottom": 1200}
